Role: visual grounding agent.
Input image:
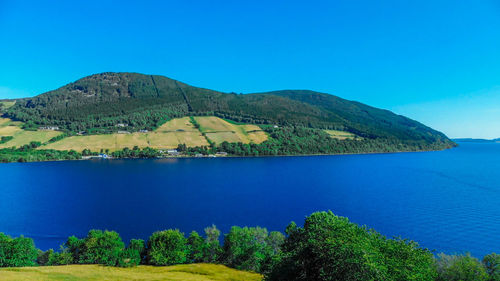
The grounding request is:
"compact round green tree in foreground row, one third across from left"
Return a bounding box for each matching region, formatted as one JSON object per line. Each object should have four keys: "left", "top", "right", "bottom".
{"left": 147, "top": 229, "right": 188, "bottom": 265}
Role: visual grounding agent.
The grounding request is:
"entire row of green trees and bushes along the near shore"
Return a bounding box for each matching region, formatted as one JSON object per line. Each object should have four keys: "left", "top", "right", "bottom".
{"left": 0, "top": 212, "right": 500, "bottom": 281}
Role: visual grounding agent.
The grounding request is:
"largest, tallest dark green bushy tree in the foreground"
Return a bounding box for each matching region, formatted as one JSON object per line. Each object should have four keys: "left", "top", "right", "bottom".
{"left": 266, "top": 212, "right": 436, "bottom": 280}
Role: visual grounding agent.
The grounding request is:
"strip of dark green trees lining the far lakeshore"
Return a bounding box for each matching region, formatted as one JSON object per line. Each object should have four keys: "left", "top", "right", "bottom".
{"left": 0, "top": 126, "right": 453, "bottom": 162}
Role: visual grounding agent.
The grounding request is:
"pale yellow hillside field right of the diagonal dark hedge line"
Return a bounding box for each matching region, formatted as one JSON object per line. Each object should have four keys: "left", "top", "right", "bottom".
{"left": 194, "top": 116, "right": 267, "bottom": 144}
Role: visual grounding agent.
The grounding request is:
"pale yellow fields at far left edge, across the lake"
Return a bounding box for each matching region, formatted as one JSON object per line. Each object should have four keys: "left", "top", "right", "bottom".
{"left": 0, "top": 118, "right": 62, "bottom": 148}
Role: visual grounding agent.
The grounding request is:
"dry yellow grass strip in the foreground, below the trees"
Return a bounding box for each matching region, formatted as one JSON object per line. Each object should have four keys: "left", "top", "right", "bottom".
{"left": 0, "top": 264, "right": 262, "bottom": 281}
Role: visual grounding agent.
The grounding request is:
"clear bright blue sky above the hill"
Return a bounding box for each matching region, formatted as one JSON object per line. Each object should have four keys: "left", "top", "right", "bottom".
{"left": 0, "top": 0, "right": 500, "bottom": 138}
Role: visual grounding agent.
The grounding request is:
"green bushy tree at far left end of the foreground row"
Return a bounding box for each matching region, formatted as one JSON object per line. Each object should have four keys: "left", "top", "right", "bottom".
{"left": 0, "top": 232, "right": 38, "bottom": 267}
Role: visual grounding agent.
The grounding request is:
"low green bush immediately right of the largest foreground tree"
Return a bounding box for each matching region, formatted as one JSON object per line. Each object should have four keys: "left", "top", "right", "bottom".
{"left": 436, "top": 253, "right": 488, "bottom": 281}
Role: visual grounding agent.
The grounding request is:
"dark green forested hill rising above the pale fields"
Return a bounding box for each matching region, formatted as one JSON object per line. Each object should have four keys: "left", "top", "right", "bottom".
{"left": 0, "top": 73, "right": 451, "bottom": 147}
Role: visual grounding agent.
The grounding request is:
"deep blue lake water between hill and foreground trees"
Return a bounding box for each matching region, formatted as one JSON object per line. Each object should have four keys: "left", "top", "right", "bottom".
{"left": 0, "top": 143, "right": 500, "bottom": 257}
